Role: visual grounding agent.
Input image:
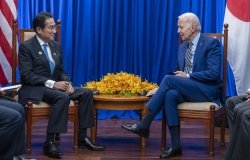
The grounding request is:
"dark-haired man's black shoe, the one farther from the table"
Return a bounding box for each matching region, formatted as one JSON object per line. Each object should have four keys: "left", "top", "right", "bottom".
{"left": 43, "top": 142, "right": 63, "bottom": 158}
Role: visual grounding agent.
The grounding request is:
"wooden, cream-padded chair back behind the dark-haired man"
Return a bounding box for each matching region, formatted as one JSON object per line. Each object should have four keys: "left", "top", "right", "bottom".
{"left": 11, "top": 20, "right": 61, "bottom": 85}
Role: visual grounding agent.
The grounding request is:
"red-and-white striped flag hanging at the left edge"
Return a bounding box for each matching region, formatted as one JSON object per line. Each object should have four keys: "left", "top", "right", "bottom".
{"left": 0, "top": 0, "right": 17, "bottom": 85}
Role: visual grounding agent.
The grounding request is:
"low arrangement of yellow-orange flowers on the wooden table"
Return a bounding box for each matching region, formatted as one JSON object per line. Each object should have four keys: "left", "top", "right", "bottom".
{"left": 85, "top": 72, "right": 158, "bottom": 96}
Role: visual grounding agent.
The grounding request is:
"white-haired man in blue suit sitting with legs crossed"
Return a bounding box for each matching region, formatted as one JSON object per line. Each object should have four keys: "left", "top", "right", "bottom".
{"left": 122, "top": 13, "right": 222, "bottom": 158}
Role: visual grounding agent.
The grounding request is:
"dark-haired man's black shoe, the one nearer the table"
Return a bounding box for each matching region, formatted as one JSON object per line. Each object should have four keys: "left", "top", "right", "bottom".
{"left": 78, "top": 137, "right": 105, "bottom": 151}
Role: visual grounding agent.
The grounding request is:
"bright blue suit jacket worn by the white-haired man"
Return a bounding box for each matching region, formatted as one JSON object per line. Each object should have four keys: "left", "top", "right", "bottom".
{"left": 176, "top": 34, "right": 222, "bottom": 103}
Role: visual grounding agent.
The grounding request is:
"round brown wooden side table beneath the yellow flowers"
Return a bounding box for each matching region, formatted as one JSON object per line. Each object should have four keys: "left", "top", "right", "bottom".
{"left": 91, "top": 95, "right": 149, "bottom": 147}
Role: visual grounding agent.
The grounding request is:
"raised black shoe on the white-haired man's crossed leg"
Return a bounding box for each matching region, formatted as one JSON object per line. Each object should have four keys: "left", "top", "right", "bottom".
{"left": 122, "top": 124, "right": 149, "bottom": 138}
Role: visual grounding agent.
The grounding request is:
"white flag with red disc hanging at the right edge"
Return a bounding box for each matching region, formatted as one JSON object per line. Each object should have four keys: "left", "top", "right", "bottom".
{"left": 224, "top": 0, "right": 250, "bottom": 95}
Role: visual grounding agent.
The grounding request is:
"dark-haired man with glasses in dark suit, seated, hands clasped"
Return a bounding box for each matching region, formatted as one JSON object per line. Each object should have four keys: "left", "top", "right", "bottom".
{"left": 19, "top": 12, "right": 104, "bottom": 158}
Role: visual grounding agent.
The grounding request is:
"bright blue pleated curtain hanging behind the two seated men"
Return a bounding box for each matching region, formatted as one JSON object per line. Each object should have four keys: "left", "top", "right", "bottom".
{"left": 18, "top": 0, "right": 235, "bottom": 118}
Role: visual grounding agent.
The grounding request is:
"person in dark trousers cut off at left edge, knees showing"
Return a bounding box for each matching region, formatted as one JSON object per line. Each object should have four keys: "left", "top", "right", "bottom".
{"left": 0, "top": 88, "right": 32, "bottom": 160}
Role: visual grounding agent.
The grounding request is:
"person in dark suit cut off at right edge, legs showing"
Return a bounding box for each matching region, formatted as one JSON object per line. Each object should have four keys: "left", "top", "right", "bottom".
{"left": 225, "top": 90, "right": 250, "bottom": 160}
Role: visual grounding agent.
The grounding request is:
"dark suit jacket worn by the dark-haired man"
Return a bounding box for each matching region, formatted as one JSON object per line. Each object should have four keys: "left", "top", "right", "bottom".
{"left": 18, "top": 36, "right": 69, "bottom": 105}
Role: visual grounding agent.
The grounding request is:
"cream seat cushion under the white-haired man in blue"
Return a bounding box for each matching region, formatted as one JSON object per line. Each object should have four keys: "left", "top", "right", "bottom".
{"left": 178, "top": 102, "right": 221, "bottom": 111}
